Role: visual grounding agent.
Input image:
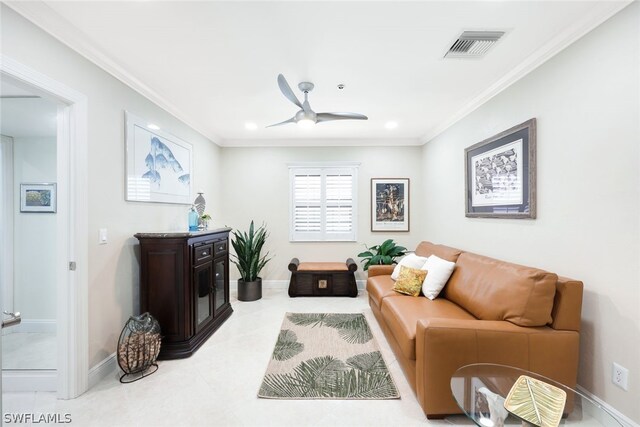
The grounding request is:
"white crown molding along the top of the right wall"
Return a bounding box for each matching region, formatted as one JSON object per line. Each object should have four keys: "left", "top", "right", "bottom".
{"left": 420, "top": 0, "right": 633, "bottom": 144}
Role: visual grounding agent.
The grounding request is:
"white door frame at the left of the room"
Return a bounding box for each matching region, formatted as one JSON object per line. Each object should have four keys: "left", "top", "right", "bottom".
{"left": 0, "top": 55, "right": 89, "bottom": 399}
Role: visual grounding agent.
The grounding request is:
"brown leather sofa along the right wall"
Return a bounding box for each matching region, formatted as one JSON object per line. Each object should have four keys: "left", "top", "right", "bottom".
{"left": 367, "top": 242, "right": 582, "bottom": 418}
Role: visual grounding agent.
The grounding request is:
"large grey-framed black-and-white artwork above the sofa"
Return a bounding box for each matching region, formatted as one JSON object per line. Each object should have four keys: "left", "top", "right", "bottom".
{"left": 464, "top": 118, "right": 536, "bottom": 219}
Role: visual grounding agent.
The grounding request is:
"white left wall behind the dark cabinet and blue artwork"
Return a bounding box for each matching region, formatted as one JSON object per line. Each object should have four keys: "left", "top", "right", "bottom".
{"left": 1, "top": 5, "right": 224, "bottom": 367}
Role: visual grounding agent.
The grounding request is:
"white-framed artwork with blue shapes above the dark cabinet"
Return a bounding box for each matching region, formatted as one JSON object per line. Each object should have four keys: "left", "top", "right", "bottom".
{"left": 125, "top": 111, "right": 193, "bottom": 204}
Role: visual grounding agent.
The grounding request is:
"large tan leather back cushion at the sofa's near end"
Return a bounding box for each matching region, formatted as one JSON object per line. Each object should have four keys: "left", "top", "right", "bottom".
{"left": 441, "top": 252, "right": 558, "bottom": 326}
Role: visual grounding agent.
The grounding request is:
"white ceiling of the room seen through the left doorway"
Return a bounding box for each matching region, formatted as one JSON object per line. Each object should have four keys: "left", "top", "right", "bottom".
{"left": 0, "top": 79, "right": 58, "bottom": 138}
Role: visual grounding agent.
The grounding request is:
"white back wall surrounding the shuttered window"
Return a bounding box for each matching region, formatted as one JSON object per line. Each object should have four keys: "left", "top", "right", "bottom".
{"left": 220, "top": 147, "right": 422, "bottom": 287}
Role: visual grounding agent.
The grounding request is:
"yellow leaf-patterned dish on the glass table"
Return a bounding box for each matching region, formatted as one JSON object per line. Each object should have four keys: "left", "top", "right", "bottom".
{"left": 504, "top": 375, "right": 567, "bottom": 427}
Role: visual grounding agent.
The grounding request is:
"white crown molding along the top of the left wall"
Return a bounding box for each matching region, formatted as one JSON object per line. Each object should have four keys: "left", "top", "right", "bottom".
{"left": 3, "top": 0, "right": 223, "bottom": 145}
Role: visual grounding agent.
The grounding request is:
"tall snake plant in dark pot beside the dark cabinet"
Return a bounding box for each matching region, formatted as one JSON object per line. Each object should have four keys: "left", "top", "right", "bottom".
{"left": 231, "top": 221, "right": 270, "bottom": 301}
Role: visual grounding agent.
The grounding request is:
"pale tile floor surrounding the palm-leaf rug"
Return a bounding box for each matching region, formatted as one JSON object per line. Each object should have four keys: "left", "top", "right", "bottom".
{"left": 3, "top": 286, "right": 472, "bottom": 427}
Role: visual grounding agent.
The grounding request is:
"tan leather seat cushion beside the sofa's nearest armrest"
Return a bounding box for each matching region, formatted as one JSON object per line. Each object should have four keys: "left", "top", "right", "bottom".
{"left": 380, "top": 295, "right": 475, "bottom": 360}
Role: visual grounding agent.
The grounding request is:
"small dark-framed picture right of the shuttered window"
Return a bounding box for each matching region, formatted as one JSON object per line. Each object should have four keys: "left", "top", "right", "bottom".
{"left": 371, "top": 178, "right": 409, "bottom": 231}
